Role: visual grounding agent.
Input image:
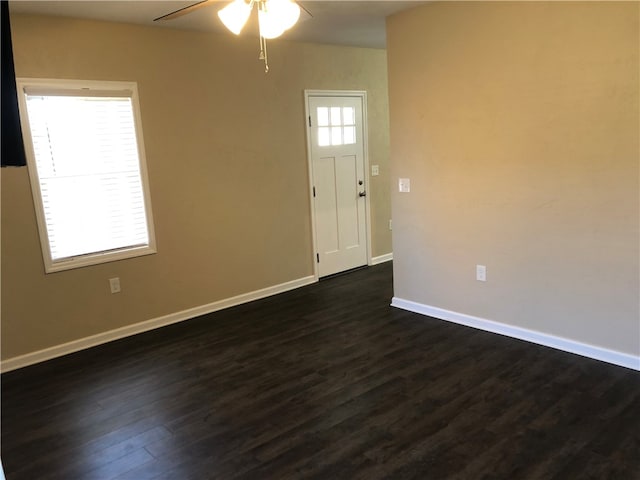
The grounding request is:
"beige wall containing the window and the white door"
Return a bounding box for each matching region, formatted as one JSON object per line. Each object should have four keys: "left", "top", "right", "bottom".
{"left": 1, "top": 15, "right": 391, "bottom": 359}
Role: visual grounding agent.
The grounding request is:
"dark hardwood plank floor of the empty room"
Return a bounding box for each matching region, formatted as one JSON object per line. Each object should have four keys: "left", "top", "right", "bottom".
{"left": 2, "top": 264, "right": 640, "bottom": 480}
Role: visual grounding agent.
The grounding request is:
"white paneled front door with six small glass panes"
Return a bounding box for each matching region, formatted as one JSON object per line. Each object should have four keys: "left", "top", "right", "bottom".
{"left": 307, "top": 95, "right": 368, "bottom": 277}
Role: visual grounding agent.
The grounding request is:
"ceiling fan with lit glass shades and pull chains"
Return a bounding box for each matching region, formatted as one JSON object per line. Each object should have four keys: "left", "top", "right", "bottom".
{"left": 153, "top": 0, "right": 312, "bottom": 73}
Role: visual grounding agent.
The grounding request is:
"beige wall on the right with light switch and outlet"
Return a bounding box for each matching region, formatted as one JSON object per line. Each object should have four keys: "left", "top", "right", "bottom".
{"left": 387, "top": 2, "right": 640, "bottom": 355}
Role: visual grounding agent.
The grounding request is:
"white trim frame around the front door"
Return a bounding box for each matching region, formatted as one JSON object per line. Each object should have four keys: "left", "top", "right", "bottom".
{"left": 304, "top": 90, "right": 372, "bottom": 281}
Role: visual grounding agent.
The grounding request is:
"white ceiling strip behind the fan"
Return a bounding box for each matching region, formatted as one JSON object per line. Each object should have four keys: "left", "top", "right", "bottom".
{"left": 9, "top": 0, "right": 426, "bottom": 48}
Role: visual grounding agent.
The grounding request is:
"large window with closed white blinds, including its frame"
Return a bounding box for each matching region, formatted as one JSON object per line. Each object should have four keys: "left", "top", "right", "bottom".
{"left": 17, "top": 79, "right": 155, "bottom": 272}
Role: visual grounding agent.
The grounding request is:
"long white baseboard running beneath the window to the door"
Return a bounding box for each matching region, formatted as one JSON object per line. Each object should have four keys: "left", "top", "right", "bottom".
{"left": 0, "top": 275, "right": 317, "bottom": 373}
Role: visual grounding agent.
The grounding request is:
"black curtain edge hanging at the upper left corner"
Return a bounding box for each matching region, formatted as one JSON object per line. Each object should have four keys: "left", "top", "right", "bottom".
{"left": 0, "top": 0, "right": 26, "bottom": 167}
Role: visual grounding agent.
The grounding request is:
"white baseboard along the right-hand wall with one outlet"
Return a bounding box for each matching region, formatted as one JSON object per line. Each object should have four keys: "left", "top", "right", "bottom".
{"left": 391, "top": 297, "right": 640, "bottom": 370}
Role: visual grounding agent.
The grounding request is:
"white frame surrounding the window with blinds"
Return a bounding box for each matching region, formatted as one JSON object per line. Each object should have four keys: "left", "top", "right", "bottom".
{"left": 16, "top": 78, "right": 157, "bottom": 273}
